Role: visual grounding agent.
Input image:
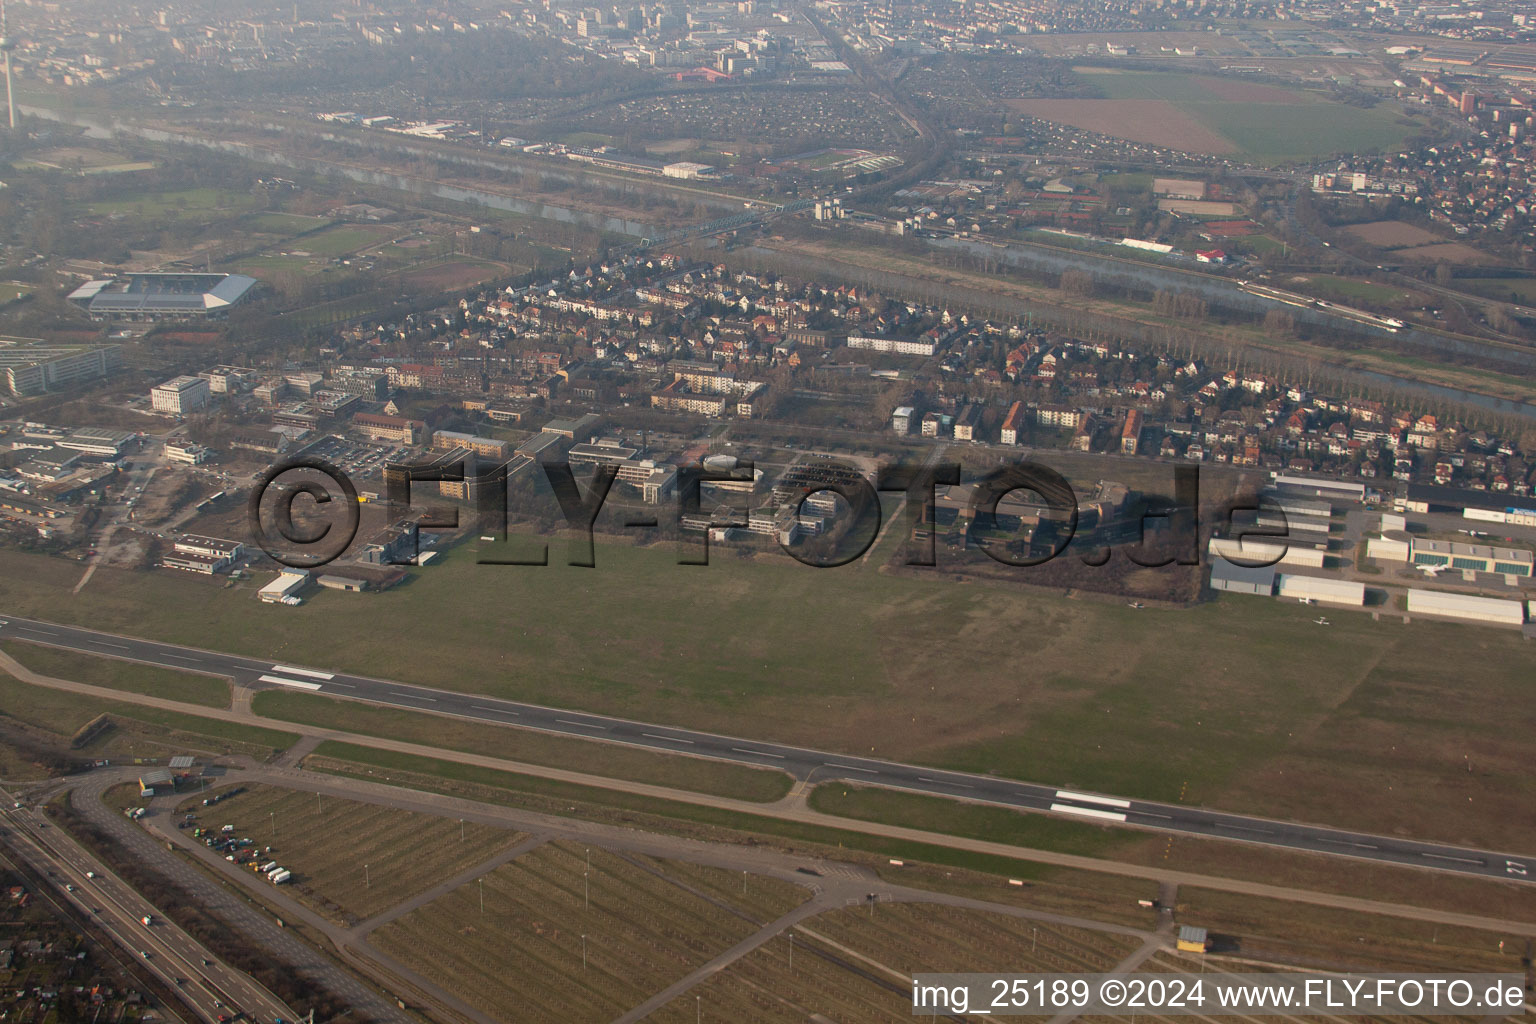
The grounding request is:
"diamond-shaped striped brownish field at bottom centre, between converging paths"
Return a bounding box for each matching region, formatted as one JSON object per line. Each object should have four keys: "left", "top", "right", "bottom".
{"left": 369, "top": 843, "right": 809, "bottom": 1024}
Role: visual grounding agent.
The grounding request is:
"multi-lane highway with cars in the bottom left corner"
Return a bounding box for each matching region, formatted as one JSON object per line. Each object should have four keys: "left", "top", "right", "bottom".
{"left": 0, "top": 791, "right": 293, "bottom": 1024}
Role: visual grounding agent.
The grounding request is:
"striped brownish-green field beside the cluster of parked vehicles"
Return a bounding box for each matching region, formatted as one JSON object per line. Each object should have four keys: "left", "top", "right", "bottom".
{"left": 180, "top": 786, "right": 525, "bottom": 926}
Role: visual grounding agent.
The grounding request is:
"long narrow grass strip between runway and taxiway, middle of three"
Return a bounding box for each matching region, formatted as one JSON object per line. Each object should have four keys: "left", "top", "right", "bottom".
{"left": 250, "top": 691, "right": 791, "bottom": 803}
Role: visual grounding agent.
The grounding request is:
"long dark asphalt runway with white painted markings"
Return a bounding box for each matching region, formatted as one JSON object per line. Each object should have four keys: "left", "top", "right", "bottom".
{"left": 0, "top": 613, "right": 1536, "bottom": 883}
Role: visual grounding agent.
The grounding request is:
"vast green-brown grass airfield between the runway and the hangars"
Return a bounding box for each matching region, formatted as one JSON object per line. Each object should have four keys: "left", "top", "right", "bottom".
{"left": 0, "top": 539, "right": 1536, "bottom": 846}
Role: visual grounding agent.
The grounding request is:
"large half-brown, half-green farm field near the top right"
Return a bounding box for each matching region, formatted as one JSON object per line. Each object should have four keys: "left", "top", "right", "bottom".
{"left": 1009, "top": 68, "right": 1413, "bottom": 163}
